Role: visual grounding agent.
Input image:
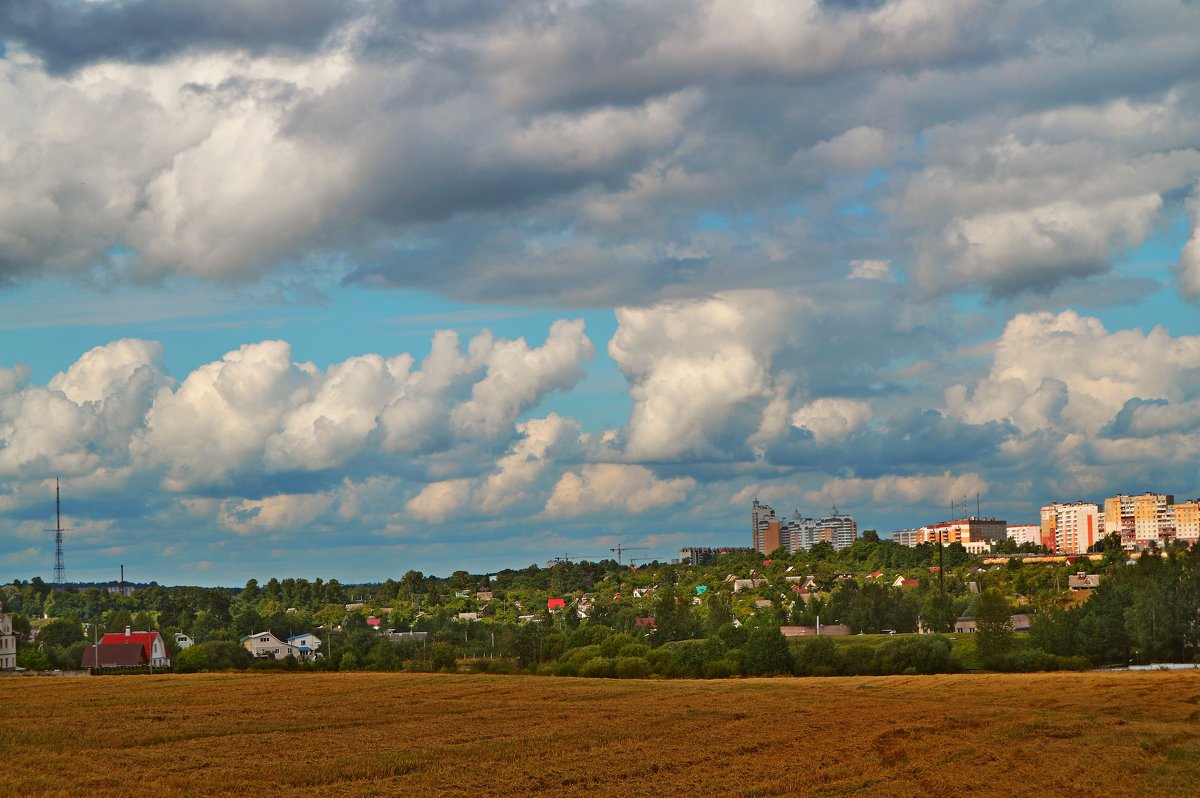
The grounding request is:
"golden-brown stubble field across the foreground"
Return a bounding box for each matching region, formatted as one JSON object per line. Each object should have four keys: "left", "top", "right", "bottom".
{"left": 0, "top": 672, "right": 1200, "bottom": 798}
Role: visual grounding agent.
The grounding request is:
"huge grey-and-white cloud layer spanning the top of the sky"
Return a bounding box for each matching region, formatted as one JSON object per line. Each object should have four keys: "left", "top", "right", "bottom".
{"left": 0, "top": 0, "right": 1200, "bottom": 305}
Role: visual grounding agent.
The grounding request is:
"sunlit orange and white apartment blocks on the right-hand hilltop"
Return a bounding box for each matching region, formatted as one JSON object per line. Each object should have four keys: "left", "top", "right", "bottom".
{"left": 892, "top": 484, "right": 1200, "bottom": 554}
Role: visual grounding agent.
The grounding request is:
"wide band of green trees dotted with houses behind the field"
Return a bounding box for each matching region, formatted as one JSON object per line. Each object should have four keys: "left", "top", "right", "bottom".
{"left": 0, "top": 532, "right": 1200, "bottom": 678}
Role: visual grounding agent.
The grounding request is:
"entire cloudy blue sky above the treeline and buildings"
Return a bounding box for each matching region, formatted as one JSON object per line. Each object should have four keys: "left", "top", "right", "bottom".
{"left": 0, "top": 0, "right": 1200, "bottom": 586}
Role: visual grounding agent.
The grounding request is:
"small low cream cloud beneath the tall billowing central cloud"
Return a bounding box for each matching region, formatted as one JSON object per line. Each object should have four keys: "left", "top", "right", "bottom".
{"left": 544, "top": 463, "right": 696, "bottom": 518}
